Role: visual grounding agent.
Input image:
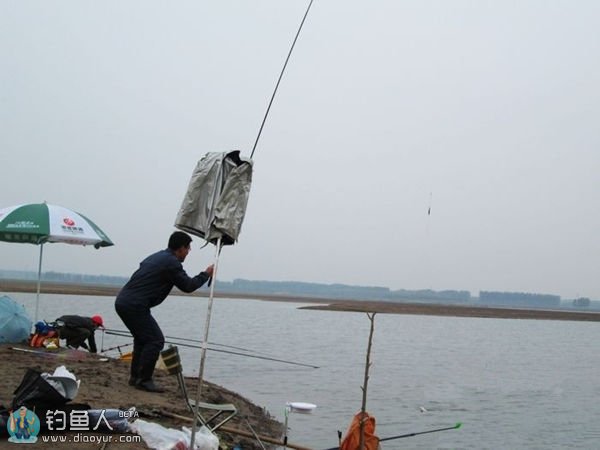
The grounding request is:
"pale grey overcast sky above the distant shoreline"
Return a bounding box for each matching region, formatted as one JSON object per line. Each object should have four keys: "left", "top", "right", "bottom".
{"left": 0, "top": 0, "right": 600, "bottom": 299}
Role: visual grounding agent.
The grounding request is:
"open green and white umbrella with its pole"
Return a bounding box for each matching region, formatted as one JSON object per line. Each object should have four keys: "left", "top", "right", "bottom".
{"left": 0, "top": 203, "right": 114, "bottom": 322}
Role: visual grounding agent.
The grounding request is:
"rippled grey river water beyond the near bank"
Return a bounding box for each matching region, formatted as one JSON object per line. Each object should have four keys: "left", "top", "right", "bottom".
{"left": 9, "top": 293, "right": 600, "bottom": 450}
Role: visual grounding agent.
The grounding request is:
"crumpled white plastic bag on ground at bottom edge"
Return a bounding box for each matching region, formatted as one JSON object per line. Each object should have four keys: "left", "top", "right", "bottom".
{"left": 129, "top": 419, "right": 219, "bottom": 450}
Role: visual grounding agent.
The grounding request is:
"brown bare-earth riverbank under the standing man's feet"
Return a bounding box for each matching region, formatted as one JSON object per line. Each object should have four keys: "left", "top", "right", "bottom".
{"left": 0, "top": 344, "right": 283, "bottom": 450}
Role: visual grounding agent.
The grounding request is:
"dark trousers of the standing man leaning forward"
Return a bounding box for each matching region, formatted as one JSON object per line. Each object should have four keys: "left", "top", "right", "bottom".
{"left": 115, "top": 305, "right": 165, "bottom": 382}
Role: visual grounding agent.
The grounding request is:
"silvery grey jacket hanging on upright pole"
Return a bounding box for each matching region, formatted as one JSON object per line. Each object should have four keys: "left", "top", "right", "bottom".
{"left": 175, "top": 150, "right": 252, "bottom": 245}
